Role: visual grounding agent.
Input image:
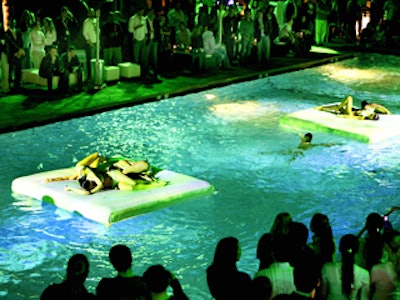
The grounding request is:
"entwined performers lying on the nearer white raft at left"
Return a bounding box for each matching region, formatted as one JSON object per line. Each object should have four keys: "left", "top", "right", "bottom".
{"left": 46, "top": 152, "right": 166, "bottom": 195}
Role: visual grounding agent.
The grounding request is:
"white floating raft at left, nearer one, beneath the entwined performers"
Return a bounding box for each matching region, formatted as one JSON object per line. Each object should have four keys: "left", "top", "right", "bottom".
{"left": 11, "top": 168, "right": 213, "bottom": 226}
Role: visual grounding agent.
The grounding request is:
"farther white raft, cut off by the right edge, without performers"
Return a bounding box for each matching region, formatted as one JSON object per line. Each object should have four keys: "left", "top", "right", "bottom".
{"left": 280, "top": 108, "right": 400, "bottom": 143}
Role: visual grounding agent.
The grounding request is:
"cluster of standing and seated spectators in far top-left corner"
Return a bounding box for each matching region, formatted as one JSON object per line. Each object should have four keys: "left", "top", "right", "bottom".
{"left": 0, "top": 6, "right": 82, "bottom": 93}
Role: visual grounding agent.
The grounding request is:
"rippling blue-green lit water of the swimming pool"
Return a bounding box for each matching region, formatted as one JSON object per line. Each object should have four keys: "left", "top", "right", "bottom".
{"left": 0, "top": 54, "right": 400, "bottom": 300}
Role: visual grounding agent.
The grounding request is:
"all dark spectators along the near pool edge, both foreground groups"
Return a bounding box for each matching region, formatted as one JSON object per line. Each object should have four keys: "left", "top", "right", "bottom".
{"left": 41, "top": 207, "right": 400, "bottom": 300}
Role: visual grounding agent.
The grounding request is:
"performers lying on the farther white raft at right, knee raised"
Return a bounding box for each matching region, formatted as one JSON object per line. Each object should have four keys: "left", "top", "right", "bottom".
{"left": 314, "top": 96, "right": 379, "bottom": 120}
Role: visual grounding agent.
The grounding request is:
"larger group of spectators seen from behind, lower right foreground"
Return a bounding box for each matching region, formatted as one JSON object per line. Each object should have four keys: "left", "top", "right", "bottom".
{"left": 206, "top": 207, "right": 400, "bottom": 300}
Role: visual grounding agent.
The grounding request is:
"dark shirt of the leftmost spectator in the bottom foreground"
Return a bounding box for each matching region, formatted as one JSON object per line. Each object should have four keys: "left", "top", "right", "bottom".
{"left": 40, "top": 282, "right": 96, "bottom": 300}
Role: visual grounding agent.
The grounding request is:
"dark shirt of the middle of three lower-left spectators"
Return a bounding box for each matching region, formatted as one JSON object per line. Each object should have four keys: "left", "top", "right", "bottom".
{"left": 96, "top": 276, "right": 150, "bottom": 300}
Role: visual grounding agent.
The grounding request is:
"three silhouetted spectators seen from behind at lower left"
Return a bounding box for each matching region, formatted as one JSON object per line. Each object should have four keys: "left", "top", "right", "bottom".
{"left": 40, "top": 244, "right": 189, "bottom": 300}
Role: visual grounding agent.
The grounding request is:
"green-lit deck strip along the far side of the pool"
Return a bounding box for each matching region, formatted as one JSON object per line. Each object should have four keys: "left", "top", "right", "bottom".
{"left": 0, "top": 47, "right": 357, "bottom": 133}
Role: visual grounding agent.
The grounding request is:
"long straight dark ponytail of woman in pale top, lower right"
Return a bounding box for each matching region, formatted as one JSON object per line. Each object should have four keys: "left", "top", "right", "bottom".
{"left": 339, "top": 234, "right": 359, "bottom": 296}
